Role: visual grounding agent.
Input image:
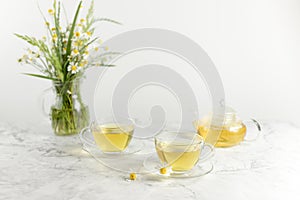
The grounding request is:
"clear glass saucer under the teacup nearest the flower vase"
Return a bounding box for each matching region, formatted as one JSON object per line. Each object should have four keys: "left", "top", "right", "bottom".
{"left": 79, "top": 128, "right": 144, "bottom": 157}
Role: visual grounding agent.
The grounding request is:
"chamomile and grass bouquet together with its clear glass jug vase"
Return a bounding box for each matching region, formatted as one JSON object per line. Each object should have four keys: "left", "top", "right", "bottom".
{"left": 15, "top": 0, "right": 119, "bottom": 135}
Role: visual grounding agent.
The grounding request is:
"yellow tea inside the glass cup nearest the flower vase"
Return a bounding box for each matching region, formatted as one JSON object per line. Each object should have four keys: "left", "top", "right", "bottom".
{"left": 92, "top": 123, "right": 134, "bottom": 152}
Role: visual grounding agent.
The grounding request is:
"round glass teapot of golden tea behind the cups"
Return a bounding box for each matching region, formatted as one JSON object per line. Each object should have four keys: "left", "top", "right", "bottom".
{"left": 194, "top": 107, "right": 261, "bottom": 147}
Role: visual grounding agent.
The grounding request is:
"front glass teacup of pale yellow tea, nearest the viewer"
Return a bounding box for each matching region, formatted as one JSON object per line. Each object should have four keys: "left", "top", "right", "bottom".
{"left": 155, "top": 131, "right": 204, "bottom": 173}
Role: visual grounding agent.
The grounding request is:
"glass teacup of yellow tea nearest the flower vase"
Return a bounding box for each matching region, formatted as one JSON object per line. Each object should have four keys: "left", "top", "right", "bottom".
{"left": 82, "top": 119, "right": 134, "bottom": 153}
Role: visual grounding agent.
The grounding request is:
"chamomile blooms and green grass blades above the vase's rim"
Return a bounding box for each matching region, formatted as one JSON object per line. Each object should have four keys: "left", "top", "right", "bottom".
{"left": 15, "top": 0, "right": 118, "bottom": 82}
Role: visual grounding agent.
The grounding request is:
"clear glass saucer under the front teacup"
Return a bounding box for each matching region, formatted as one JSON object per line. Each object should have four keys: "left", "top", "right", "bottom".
{"left": 143, "top": 145, "right": 214, "bottom": 178}
